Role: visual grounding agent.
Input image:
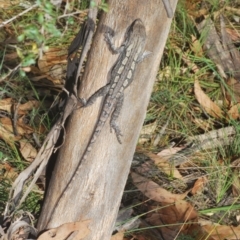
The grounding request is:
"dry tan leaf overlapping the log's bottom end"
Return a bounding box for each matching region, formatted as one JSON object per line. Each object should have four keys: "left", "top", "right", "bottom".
{"left": 38, "top": 220, "right": 91, "bottom": 240}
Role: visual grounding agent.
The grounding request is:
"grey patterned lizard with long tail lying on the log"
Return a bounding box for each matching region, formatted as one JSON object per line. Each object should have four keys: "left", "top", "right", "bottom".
{"left": 47, "top": 19, "right": 150, "bottom": 225}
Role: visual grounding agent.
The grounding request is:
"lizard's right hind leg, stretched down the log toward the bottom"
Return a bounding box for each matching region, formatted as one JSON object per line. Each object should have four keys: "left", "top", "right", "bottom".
{"left": 110, "top": 94, "right": 124, "bottom": 144}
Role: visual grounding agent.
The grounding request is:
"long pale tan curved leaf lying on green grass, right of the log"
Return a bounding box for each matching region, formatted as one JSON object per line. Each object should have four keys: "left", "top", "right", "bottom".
{"left": 194, "top": 80, "right": 223, "bottom": 118}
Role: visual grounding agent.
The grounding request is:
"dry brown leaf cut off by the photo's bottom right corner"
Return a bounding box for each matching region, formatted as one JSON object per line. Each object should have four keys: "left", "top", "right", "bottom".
{"left": 202, "top": 225, "right": 240, "bottom": 240}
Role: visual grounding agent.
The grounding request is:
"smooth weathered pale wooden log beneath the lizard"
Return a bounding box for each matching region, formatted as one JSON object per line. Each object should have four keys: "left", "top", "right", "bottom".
{"left": 38, "top": 0, "right": 177, "bottom": 240}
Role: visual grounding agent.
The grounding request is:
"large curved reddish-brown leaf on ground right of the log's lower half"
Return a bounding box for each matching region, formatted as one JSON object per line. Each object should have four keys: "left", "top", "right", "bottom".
{"left": 131, "top": 172, "right": 189, "bottom": 203}
